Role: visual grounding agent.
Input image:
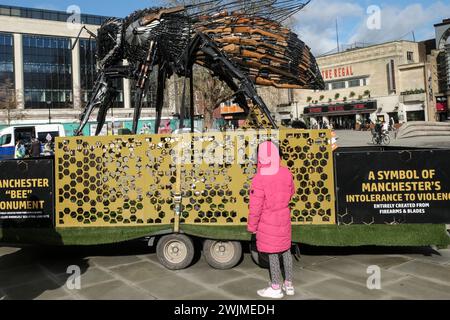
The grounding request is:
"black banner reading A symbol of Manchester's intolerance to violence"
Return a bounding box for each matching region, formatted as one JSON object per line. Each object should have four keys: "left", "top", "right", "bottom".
{"left": 335, "top": 150, "right": 450, "bottom": 224}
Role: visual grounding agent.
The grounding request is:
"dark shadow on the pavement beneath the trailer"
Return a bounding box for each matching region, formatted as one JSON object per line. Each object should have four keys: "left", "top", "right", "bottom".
{"left": 0, "top": 232, "right": 439, "bottom": 300}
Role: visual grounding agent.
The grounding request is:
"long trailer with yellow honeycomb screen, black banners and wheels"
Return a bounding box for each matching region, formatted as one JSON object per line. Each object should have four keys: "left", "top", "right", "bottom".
{"left": 0, "top": 129, "right": 450, "bottom": 270}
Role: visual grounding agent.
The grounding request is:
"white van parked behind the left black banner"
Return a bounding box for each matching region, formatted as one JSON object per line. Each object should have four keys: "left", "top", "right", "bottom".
{"left": 0, "top": 124, "right": 66, "bottom": 159}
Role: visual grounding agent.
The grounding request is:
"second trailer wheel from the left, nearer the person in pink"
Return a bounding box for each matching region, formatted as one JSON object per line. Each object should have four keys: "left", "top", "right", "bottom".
{"left": 203, "top": 240, "right": 242, "bottom": 270}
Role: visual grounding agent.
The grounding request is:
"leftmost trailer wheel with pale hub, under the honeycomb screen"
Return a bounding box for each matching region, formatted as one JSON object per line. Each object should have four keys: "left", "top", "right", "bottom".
{"left": 156, "top": 234, "right": 194, "bottom": 270}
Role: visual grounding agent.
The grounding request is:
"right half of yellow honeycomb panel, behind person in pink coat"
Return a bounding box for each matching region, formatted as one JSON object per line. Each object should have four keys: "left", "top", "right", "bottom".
{"left": 181, "top": 130, "right": 335, "bottom": 225}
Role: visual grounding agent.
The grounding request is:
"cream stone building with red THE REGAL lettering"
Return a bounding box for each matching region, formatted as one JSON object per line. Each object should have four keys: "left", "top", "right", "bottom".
{"left": 292, "top": 41, "right": 434, "bottom": 129}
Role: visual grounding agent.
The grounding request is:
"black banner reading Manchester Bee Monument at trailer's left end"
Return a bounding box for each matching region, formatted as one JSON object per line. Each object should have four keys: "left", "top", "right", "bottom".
{"left": 0, "top": 159, "right": 54, "bottom": 227}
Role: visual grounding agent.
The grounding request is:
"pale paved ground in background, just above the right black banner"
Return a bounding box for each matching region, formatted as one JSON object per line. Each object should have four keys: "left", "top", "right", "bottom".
{"left": 336, "top": 130, "right": 450, "bottom": 148}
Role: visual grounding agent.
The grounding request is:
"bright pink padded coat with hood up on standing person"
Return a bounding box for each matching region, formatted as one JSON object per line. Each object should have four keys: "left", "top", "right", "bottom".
{"left": 247, "top": 141, "right": 295, "bottom": 253}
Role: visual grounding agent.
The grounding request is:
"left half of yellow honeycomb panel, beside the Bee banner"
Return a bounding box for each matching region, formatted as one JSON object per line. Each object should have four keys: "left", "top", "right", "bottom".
{"left": 55, "top": 135, "right": 181, "bottom": 227}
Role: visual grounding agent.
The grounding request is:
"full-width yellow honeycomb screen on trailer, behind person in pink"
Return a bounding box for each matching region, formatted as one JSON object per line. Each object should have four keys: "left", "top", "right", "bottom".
{"left": 55, "top": 130, "right": 335, "bottom": 227}
